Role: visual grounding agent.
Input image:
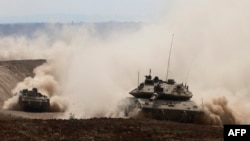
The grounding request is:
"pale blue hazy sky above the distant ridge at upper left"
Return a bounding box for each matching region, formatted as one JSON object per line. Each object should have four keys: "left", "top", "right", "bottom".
{"left": 0, "top": 0, "right": 171, "bottom": 23}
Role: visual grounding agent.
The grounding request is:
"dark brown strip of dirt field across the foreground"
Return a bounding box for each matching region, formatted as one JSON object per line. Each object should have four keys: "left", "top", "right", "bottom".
{"left": 0, "top": 118, "right": 223, "bottom": 141}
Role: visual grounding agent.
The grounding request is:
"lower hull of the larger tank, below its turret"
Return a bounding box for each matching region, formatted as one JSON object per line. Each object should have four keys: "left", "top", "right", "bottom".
{"left": 129, "top": 98, "right": 204, "bottom": 123}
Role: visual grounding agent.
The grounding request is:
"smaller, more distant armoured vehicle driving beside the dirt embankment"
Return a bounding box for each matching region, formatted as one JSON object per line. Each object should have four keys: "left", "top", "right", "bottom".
{"left": 18, "top": 88, "right": 50, "bottom": 112}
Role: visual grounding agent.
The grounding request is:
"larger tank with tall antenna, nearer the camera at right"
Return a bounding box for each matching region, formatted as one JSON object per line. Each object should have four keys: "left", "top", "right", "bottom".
{"left": 126, "top": 70, "right": 204, "bottom": 123}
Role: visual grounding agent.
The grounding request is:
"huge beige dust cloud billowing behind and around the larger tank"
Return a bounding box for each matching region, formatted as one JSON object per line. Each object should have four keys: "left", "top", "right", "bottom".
{"left": 0, "top": 0, "right": 250, "bottom": 125}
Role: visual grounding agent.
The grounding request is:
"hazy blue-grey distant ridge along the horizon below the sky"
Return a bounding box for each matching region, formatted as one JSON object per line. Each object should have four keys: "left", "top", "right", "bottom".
{"left": 0, "top": 21, "right": 142, "bottom": 37}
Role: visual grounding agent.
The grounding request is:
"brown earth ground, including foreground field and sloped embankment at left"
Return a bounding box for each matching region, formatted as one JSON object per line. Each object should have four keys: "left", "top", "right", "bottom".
{"left": 0, "top": 60, "right": 223, "bottom": 141}
